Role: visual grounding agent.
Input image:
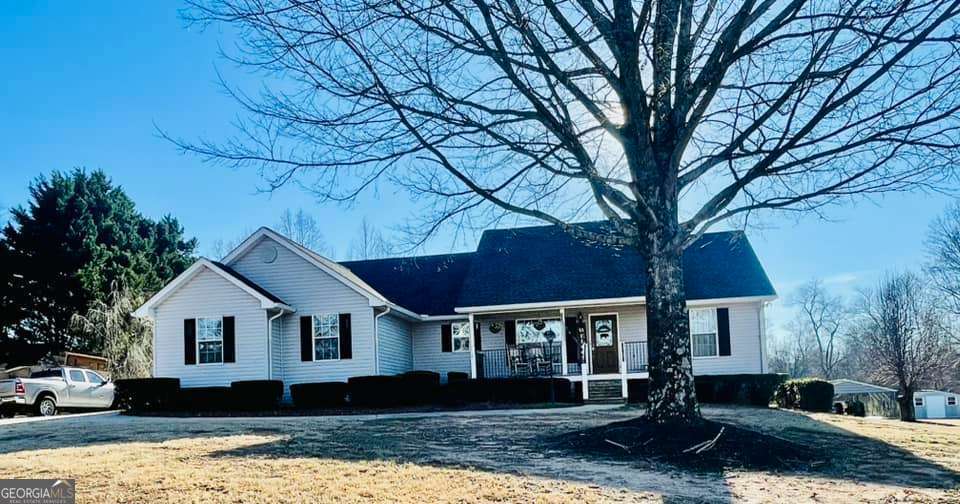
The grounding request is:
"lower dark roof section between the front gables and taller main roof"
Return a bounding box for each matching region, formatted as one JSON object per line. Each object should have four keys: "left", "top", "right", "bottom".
{"left": 340, "top": 252, "right": 474, "bottom": 315}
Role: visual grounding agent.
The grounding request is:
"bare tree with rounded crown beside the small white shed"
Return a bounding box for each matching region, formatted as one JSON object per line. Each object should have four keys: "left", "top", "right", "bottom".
{"left": 858, "top": 273, "right": 956, "bottom": 421}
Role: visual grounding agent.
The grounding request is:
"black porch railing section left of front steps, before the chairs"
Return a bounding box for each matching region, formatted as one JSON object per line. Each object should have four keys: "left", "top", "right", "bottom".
{"left": 477, "top": 343, "right": 563, "bottom": 378}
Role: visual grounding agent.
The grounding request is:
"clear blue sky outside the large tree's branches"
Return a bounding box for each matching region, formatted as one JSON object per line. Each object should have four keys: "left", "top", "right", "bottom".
{"left": 0, "top": 2, "right": 949, "bottom": 338}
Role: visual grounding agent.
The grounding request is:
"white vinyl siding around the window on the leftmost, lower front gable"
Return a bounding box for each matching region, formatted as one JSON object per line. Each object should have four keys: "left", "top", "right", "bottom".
{"left": 154, "top": 269, "right": 267, "bottom": 387}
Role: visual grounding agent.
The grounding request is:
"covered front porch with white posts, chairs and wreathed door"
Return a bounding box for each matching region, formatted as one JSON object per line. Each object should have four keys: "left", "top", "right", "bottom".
{"left": 470, "top": 303, "right": 647, "bottom": 399}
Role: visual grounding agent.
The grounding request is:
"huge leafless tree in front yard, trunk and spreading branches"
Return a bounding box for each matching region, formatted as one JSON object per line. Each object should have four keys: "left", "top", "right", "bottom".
{"left": 175, "top": 0, "right": 960, "bottom": 421}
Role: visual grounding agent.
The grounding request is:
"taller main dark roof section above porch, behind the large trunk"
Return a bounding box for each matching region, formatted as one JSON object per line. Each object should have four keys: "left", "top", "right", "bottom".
{"left": 456, "top": 222, "right": 775, "bottom": 307}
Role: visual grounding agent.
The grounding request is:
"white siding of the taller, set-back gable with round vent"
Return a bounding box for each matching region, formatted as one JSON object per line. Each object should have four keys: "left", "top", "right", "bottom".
{"left": 230, "top": 238, "right": 374, "bottom": 397}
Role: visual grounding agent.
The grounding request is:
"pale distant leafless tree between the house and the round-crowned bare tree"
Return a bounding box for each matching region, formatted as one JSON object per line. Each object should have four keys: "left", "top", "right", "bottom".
{"left": 792, "top": 279, "right": 850, "bottom": 380}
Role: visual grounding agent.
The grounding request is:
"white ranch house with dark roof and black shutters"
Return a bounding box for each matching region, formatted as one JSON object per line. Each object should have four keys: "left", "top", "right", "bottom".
{"left": 136, "top": 222, "right": 776, "bottom": 399}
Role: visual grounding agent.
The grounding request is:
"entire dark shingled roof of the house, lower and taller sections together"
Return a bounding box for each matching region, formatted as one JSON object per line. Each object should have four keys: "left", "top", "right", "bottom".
{"left": 340, "top": 222, "right": 776, "bottom": 315}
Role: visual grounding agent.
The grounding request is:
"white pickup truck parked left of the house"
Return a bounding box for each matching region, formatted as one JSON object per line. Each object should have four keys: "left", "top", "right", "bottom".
{"left": 0, "top": 367, "right": 113, "bottom": 417}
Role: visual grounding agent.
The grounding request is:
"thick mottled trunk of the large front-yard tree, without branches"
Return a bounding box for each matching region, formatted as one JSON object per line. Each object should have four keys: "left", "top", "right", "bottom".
{"left": 644, "top": 239, "right": 700, "bottom": 423}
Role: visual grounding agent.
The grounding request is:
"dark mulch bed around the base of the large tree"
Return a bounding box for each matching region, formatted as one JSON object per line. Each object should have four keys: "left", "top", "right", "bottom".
{"left": 549, "top": 417, "right": 828, "bottom": 471}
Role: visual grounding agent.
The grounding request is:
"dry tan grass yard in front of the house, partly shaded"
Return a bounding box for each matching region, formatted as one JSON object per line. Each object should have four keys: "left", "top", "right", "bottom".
{"left": 0, "top": 407, "right": 960, "bottom": 503}
